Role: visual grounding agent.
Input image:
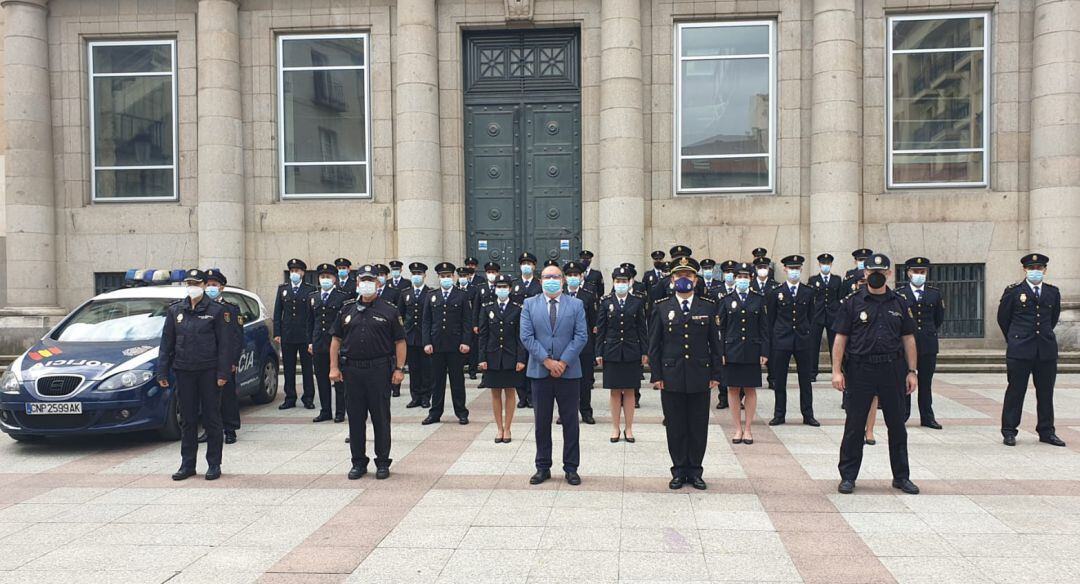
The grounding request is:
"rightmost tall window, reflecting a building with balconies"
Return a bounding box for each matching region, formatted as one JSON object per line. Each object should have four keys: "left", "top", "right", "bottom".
{"left": 887, "top": 13, "right": 990, "bottom": 188}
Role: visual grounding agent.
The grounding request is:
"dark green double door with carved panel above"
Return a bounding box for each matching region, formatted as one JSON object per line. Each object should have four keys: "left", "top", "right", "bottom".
{"left": 463, "top": 29, "right": 581, "bottom": 272}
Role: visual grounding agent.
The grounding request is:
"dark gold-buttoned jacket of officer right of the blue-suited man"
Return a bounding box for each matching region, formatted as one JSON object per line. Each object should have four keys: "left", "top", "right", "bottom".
{"left": 649, "top": 295, "right": 720, "bottom": 393}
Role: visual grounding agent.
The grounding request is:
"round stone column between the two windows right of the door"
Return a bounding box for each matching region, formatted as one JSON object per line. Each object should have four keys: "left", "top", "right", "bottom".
{"left": 809, "top": 0, "right": 862, "bottom": 266}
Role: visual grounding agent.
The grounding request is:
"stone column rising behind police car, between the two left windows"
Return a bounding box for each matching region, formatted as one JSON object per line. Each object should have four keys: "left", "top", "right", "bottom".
{"left": 195, "top": 0, "right": 245, "bottom": 285}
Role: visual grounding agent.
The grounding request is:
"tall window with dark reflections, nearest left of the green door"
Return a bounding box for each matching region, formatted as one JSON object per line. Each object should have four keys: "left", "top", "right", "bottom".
{"left": 278, "top": 33, "right": 372, "bottom": 199}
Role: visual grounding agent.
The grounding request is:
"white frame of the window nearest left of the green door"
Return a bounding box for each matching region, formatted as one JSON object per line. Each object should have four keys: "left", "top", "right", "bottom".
{"left": 274, "top": 32, "right": 375, "bottom": 201}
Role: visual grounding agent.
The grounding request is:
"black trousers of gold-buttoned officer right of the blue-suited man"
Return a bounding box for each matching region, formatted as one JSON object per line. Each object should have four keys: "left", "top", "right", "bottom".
{"left": 660, "top": 389, "right": 710, "bottom": 480}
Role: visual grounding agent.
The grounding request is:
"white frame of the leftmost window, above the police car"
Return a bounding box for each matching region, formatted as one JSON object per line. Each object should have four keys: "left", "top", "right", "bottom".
{"left": 86, "top": 39, "right": 180, "bottom": 204}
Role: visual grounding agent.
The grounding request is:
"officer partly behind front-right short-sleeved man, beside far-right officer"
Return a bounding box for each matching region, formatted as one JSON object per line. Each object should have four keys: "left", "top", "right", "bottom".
{"left": 896, "top": 257, "right": 945, "bottom": 430}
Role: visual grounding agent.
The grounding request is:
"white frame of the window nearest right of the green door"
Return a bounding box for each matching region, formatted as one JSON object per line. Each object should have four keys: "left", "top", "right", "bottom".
{"left": 672, "top": 19, "right": 779, "bottom": 196}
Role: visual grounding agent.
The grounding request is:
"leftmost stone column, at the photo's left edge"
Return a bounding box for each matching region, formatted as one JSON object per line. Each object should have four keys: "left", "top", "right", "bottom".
{"left": 0, "top": 0, "right": 57, "bottom": 309}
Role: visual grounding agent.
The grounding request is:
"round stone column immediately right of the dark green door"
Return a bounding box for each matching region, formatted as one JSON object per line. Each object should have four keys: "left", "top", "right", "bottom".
{"left": 596, "top": 0, "right": 646, "bottom": 269}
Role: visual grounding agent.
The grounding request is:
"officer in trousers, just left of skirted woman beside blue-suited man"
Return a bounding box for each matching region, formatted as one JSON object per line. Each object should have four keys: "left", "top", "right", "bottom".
{"left": 422, "top": 261, "right": 473, "bottom": 425}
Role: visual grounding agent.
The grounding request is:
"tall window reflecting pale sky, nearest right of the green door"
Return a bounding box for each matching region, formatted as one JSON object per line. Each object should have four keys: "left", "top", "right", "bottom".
{"left": 675, "top": 21, "right": 777, "bottom": 193}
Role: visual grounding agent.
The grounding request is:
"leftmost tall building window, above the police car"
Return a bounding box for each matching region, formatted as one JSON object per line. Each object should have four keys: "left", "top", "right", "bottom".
{"left": 89, "top": 40, "right": 177, "bottom": 202}
